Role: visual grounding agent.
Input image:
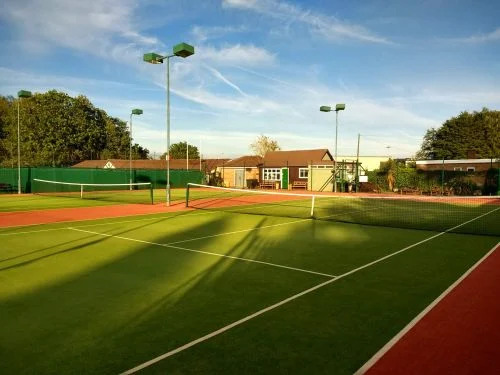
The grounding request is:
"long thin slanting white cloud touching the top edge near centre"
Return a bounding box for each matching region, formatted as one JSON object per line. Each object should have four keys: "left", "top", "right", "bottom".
{"left": 222, "top": 0, "right": 391, "bottom": 44}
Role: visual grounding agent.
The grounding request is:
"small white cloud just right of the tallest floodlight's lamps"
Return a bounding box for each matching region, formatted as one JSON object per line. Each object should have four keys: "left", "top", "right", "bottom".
{"left": 198, "top": 44, "right": 275, "bottom": 66}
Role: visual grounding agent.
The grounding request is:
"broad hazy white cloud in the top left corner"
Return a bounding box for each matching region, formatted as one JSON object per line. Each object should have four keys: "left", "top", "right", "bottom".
{"left": 0, "top": 0, "right": 160, "bottom": 60}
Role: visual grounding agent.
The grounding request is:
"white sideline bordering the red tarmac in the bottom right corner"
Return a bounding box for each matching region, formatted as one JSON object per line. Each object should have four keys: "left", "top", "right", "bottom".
{"left": 354, "top": 242, "right": 500, "bottom": 375}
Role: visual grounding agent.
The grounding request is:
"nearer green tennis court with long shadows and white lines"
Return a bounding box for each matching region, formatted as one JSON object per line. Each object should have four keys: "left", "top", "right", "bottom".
{"left": 0, "top": 189, "right": 500, "bottom": 374}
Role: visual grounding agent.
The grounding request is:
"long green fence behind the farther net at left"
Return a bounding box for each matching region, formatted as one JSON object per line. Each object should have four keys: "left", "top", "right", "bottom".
{"left": 0, "top": 167, "right": 204, "bottom": 193}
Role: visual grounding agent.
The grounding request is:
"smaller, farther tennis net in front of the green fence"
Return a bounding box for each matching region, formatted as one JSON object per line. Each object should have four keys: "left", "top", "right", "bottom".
{"left": 32, "top": 178, "right": 154, "bottom": 204}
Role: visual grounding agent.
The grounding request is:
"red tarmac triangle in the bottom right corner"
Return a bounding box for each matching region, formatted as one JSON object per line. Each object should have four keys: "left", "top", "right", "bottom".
{"left": 365, "top": 245, "right": 500, "bottom": 375}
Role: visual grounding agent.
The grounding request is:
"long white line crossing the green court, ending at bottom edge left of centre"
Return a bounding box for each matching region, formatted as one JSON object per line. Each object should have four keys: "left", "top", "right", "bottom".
{"left": 120, "top": 207, "right": 500, "bottom": 375}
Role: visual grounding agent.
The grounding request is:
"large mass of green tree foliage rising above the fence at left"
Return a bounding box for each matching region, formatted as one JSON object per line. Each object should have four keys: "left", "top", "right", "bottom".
{"left": 0, "top": 90, "right": 149, "bottom": 166}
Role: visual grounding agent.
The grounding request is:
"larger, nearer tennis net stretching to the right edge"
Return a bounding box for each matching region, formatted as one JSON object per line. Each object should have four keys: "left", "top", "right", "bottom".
{"left": 186, "top": 184, "right": 500, "bottom": 236}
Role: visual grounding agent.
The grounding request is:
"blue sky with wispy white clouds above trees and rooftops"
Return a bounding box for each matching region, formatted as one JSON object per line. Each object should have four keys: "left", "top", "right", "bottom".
{"left": 0, "top": 0, "right": 500, "bottom": 158}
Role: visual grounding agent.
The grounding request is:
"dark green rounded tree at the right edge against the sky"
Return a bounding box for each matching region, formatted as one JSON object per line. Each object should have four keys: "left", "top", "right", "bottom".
{"left": 416, "top": 108, "right": 500, "bottom": 159}
